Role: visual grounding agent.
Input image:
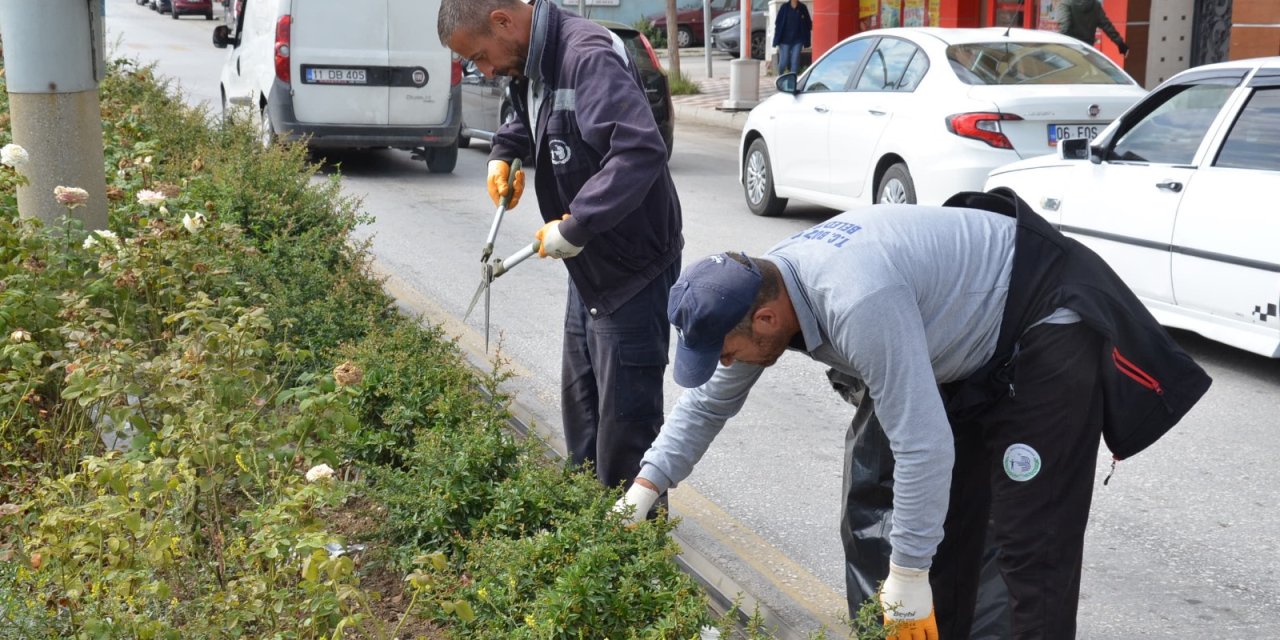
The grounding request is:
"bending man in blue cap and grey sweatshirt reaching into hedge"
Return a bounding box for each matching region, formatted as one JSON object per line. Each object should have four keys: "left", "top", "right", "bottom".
{"left": 616, "top": 192, "right": 1210, "bottom": 640}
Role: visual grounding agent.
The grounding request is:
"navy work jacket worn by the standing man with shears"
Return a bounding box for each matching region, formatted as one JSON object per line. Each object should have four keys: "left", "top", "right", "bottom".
{"left": 489, "top": 0, "right": 684, "bottom": 315}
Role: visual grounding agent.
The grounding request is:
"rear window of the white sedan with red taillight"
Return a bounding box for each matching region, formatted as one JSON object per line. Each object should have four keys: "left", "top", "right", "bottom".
{"left": 947, "top": 42, "right": 1133, "bottom": 84}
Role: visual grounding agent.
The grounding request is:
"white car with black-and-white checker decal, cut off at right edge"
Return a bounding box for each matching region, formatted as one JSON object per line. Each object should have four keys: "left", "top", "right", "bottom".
{"left": 987, "top": 58, "right": 1280, "bottom": 357}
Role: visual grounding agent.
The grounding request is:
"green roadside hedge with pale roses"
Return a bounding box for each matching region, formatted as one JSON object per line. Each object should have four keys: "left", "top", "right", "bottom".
{"left": 0, "top": 61, "right": 709, "bottom": 639}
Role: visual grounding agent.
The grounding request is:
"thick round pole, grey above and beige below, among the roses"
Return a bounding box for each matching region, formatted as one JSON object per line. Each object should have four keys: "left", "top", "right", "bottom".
{"left": 0, "top": 0, "right": 106, "bottom": 229}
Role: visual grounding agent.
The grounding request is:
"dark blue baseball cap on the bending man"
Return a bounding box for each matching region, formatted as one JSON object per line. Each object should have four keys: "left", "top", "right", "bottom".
{"left": 667, "top": 253, "right": 764, "bottom": 388}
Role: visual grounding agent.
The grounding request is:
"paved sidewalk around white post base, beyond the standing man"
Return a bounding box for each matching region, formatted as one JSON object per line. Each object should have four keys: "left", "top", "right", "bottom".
{"left": 657, "top": 47, "right": 778, "bottom": 132}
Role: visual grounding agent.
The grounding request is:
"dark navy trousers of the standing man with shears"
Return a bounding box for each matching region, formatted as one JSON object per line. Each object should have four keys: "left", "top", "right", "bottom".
{"left": 561, "top": 260, "right": 680, "bottom": 488}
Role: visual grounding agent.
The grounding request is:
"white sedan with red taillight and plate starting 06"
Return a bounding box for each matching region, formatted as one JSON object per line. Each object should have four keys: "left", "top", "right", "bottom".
{"left": 739, "top": 28, "right": 1146, "bottom": 215}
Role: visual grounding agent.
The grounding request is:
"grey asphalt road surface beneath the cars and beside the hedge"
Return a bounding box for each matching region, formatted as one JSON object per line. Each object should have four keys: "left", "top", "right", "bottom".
{"left": 106, "top": 0, "right": 1280, "bottom": 639}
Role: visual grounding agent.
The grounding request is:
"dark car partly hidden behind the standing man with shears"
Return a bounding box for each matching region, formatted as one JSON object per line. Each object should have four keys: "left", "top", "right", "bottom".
{"left": 458, "top": 20, "right": 676, "bottom": 157}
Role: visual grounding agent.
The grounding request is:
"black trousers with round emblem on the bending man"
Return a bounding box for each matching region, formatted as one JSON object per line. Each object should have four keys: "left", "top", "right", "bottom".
{"left": 929, "top": 323, "right": 1103, "bottom": 640}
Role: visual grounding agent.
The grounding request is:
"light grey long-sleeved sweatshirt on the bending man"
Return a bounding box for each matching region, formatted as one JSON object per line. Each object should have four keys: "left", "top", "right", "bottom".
{"left": 639, "top": 205, "right": 1015, "bottom": 568}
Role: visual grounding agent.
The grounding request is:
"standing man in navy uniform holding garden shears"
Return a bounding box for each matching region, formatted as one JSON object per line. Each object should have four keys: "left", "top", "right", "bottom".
{"left": 438, "top": 0, "right": 684, "bottom": 499}
